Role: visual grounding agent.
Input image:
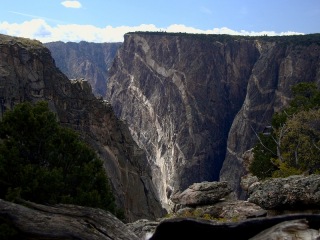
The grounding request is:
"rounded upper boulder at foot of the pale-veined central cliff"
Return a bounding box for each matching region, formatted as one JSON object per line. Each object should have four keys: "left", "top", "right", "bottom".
{"left": 171, "top": 182, "right": 232, "bottom": 206}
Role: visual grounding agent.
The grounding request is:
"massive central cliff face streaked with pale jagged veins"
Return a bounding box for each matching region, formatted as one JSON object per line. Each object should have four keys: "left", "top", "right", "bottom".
{"left": 107, "top": 33, "right": 260, "bottom": 205}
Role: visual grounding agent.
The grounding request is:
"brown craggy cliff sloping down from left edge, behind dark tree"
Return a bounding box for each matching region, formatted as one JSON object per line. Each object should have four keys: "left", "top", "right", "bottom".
{"left": 0, "top": 35, "right": 163, "bottom": 221}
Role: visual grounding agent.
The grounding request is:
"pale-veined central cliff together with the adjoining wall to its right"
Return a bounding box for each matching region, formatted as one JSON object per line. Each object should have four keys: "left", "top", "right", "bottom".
{"left": 107, "top": 33, "right": 320, "bottom": 206}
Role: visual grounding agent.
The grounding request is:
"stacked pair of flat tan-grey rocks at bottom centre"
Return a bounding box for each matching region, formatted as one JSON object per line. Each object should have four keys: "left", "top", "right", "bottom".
{"left": 172, "top": 182, "right": 267, "bottom": 222}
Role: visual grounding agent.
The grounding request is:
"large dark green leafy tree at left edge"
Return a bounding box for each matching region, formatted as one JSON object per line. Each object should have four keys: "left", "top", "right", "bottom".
{"left": 0, "top": 102, "right": 116, "bottom": 213}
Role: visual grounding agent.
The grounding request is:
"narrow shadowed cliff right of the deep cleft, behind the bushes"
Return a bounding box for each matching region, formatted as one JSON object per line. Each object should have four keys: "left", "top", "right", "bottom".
{"left": 220, "top": 35, "right": 320, "bottom": 194}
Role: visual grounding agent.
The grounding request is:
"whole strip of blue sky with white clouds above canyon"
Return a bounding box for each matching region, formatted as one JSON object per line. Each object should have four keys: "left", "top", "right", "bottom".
{"left": 0, "top": 0, "right": 320, "bottom": 42}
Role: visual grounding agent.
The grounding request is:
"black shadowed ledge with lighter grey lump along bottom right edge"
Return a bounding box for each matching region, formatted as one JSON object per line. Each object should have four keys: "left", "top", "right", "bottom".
{"left": 150, "top": 214, "right": 320, "bottom": 240}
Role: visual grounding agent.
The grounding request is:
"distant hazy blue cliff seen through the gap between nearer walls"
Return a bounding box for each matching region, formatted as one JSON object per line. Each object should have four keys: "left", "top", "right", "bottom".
{"left": 44, "top": 41, "right": 121, "bottom": 97}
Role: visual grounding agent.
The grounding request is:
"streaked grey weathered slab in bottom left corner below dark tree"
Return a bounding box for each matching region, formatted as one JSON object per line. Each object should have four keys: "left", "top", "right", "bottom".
{"left": 0, "top": 199, "right": 140, "bottom": 240}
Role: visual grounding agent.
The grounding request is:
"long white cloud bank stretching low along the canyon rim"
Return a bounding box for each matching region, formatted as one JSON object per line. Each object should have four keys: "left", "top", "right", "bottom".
{"left": 0, "top": 19, "right": 302, "bottom": 42}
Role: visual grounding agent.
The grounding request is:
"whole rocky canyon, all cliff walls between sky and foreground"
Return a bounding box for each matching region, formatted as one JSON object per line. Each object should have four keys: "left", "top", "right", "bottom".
{"left": 0, "top": 32, "right": 320, "bottom": 218}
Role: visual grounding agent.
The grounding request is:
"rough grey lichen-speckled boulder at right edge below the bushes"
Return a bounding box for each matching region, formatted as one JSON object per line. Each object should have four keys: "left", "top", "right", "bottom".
{"left": 248, "top": 175, "right": 320, "bottom": 210}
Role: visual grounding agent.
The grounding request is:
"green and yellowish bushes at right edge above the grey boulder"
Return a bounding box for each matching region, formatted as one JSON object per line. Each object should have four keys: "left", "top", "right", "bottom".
{"left": 250, "top": 83, "right": 320, "bottom": 179}
